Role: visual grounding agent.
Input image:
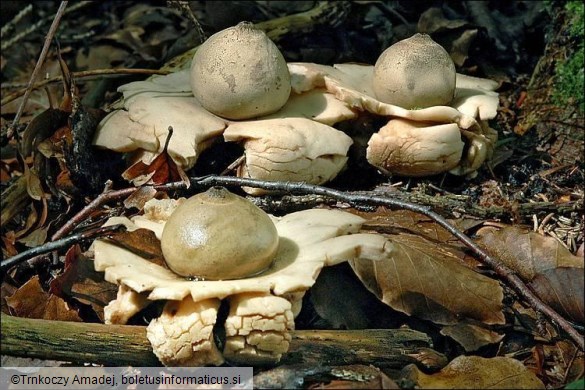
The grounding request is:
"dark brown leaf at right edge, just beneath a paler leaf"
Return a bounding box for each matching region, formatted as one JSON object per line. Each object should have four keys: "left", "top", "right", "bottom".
{"left": 528, "top": 267, "right": 585, "bottom": 324}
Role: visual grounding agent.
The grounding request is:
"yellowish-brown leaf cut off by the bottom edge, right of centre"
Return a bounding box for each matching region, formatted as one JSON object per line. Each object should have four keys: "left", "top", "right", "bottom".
{"left": 402, "top": 356, "right": 545, "bottom": 389}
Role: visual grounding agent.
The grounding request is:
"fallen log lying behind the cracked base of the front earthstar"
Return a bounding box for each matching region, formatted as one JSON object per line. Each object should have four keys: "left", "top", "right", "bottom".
{"left": 1, "top": 314, "right": 432, "bottom": 369}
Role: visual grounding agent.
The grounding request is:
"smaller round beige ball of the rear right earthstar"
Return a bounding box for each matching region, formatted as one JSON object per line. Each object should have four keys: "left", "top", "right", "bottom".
{"left": 373, "top": 34, "right": 455, "bottom": 108}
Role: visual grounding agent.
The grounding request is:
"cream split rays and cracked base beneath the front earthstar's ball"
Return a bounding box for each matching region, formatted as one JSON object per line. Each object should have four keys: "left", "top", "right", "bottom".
{"left": 93, "top": 188, "right": 393, "bottom": 366}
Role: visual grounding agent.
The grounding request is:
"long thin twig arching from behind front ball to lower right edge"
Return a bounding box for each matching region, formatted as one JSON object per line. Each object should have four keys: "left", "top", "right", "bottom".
{"left": 191, "top": 176, "right": 585, "bottom": 350}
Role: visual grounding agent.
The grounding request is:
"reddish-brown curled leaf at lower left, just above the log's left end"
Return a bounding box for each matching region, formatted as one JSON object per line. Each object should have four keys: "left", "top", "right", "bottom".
{"left": 6, "top": 276, "right": 81, "bottom": 322}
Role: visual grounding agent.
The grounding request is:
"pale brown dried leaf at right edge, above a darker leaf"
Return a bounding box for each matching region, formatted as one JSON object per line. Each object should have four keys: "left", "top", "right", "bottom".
{"left": 478, "top": 227, "right": 584, "bottom": 282}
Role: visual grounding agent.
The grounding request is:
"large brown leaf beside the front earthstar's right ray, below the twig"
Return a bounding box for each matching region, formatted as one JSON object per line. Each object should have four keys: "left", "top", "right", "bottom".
{"left": 351, "top": 234, "right": 505, "bottom": 325}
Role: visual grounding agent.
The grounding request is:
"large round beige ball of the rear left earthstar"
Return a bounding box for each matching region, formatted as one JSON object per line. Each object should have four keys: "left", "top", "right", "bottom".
{"left": 191, "top": 23, "right": 291, "bottom": 119}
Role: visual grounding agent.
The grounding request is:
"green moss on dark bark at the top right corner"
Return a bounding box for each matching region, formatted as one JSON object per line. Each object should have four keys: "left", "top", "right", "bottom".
{"left": 552, "top": 1, "right": 585, "bottom": 114}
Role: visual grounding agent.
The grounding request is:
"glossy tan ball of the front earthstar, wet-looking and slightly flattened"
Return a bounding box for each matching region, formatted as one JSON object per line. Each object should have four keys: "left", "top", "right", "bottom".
{"left": 161, "top": 187, "right": 278, "bottom": 280}
